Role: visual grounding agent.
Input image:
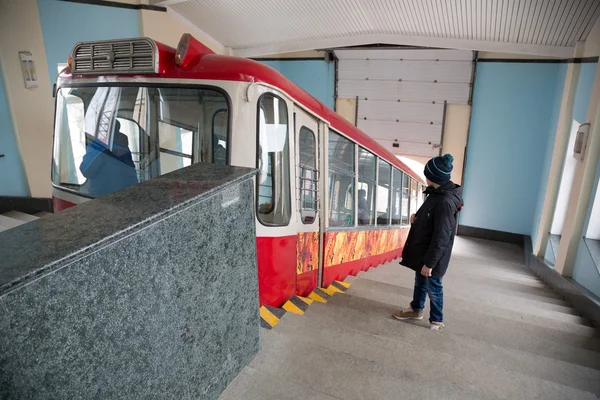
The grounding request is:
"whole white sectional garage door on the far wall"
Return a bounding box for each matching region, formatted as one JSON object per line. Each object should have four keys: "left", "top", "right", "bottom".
{"left": 335, "top": 49, "right": 473, "bottom": 157}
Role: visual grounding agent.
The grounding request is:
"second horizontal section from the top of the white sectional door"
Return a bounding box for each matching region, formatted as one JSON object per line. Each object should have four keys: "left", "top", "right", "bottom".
{"left": 338, "top": 60, "right": 473, "bottom": 83}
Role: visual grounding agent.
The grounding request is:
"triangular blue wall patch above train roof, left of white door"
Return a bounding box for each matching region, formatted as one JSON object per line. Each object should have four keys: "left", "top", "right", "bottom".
{"left": 261, "top": 60, "right": 335, "bottom": 110}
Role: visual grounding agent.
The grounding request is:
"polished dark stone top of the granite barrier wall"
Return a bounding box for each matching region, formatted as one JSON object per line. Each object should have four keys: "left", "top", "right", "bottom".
{"left": 0, "top": 164, "right": 255, "bottom": 297}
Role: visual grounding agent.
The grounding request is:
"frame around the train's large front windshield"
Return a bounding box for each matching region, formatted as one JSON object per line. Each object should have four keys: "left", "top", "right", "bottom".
{"left": 50, "top": 83, "right": 232, "bottom": 199}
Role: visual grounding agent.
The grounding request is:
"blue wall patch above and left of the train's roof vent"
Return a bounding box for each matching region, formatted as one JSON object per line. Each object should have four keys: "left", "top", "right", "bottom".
{"left": 38, "top": 0, "right": 140, "bottom": 84}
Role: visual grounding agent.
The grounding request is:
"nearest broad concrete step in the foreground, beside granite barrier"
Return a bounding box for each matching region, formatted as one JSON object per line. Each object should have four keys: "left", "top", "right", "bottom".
{"left": 250, "top": 327, "right": 596, "bottom": 400}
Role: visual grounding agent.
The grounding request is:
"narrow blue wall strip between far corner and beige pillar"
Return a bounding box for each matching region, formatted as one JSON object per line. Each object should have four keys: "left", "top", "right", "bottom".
{"left": 531, "top": 64, "right": 567, "bottom": 244}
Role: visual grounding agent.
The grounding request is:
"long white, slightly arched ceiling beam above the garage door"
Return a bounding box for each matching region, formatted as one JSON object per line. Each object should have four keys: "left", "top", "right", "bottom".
{"left": 233, "top": 34, "right": 574, "bottom": 58}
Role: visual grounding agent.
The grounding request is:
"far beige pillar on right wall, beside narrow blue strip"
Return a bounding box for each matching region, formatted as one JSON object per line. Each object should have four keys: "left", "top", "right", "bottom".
{"left": 533, "top": 43, "right": 583, "bottom": 257}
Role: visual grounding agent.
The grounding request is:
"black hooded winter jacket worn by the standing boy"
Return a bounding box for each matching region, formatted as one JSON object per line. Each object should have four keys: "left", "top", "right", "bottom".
{"left": 400, "top": 182, "right": 463, "bottom": 278}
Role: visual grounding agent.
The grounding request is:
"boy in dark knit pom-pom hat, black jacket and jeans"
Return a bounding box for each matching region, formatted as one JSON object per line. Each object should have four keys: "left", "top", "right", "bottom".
{"left": 394, "top": 154, "right": 463, "bottom": 331}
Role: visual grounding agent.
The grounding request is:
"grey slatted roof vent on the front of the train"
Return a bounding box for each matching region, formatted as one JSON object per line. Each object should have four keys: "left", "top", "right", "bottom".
{"left": 72, "top": 38, "right": 158, "bottom": 75}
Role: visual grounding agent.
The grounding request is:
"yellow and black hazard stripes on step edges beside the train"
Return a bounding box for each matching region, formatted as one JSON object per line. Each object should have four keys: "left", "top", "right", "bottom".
{"left": 260, "top": 281, "right": 350, "bottom": 329}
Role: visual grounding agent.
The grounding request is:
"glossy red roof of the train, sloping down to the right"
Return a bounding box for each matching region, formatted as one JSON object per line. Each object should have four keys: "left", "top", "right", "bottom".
{"left": 60, "top": 35, "right": 425, "bottom": 184}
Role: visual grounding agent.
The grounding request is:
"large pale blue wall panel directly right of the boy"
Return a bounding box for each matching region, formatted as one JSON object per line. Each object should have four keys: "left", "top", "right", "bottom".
{"left": 461, "top": 62, "right": 561, "bottom": 235}
